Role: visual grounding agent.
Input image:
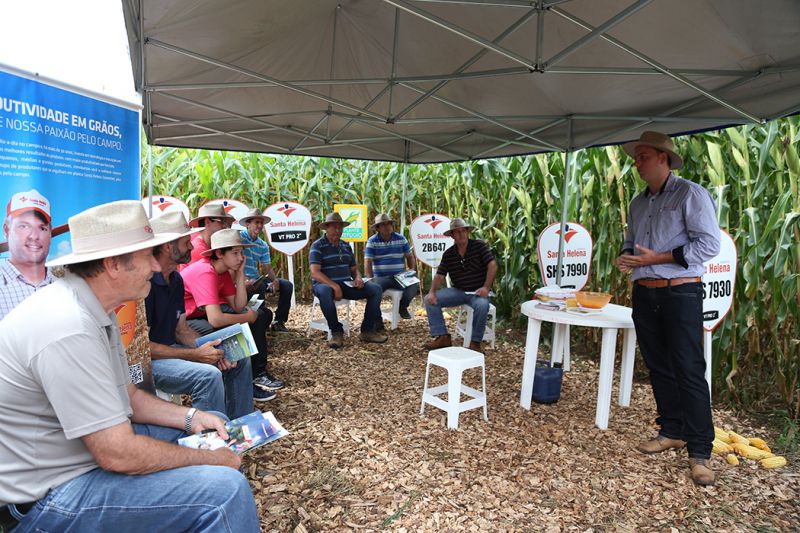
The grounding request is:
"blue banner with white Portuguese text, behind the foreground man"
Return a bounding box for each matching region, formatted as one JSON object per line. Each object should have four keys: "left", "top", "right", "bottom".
{"left": 0, "top": 71, "right": 140, "bottom": 257}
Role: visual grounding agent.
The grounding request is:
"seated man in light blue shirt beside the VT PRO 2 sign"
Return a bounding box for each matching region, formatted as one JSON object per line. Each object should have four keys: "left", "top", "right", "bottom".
{"left": 239, "top": 209, "right": 294, "bottom": 332}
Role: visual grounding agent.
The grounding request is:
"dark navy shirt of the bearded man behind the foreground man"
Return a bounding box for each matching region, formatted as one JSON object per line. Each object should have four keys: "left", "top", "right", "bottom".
{"left": 144, "top": 271, "right": 186, "bottom": 346}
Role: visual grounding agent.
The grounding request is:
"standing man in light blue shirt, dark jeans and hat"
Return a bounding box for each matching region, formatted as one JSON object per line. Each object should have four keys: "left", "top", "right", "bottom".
{"left": 617, "top": 131, "right": 720, "bottom": 485}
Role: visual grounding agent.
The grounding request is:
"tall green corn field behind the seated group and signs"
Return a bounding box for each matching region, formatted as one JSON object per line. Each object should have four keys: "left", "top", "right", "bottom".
{"left": 142, "top": 117, "right": 800, "bottom": 418}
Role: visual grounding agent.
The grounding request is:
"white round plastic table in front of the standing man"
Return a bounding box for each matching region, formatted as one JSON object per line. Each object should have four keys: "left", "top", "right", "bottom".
{"left": 519, "top": 300, "right": 636, "bottom": 429}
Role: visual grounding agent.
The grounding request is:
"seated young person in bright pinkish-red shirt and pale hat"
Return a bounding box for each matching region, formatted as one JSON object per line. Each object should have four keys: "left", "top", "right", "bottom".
{"left": 181, "top": 229, "right": 284, "bottom": 401}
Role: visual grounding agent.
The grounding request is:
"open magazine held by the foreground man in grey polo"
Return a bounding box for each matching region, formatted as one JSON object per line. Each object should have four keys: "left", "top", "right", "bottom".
{"left": 178, "top": 411, "right": 289, "bottom": 455}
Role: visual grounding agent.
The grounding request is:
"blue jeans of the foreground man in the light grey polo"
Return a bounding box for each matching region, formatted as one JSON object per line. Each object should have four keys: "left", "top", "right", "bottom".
{"left": 14, "top": 416, "right": 259, "bottom": 533}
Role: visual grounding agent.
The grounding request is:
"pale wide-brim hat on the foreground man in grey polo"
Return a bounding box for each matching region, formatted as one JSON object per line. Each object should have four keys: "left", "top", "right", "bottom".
{"left": 46, "top": 200, "right": 178, "bottom": 267}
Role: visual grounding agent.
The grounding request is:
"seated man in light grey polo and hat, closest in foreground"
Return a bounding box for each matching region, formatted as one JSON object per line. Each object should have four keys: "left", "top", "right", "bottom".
{"left": 0, "top": 200, "right": 259, "bottom": 532}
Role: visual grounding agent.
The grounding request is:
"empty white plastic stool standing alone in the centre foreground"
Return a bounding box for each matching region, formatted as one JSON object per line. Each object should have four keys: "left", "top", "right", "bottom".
{"left": 419, "top": 346, "right": 489, "bottom": 429}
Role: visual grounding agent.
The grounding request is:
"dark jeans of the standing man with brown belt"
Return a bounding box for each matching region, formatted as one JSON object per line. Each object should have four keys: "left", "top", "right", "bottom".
{"left": 633, "top": 282, "right": 714, "bottom": 459}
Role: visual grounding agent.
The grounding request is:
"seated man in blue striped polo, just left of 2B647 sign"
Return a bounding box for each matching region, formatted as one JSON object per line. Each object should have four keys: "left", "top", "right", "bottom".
{"left": 364, "top": 213, "right": 419, "bottom": 326}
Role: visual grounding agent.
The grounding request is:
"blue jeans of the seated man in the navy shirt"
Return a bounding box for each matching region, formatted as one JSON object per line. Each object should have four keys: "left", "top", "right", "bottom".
{"left": 153, "top": 350, "right": 253, "bottom": 418}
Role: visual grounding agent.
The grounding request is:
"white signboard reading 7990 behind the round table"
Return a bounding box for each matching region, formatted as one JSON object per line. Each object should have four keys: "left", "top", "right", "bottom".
{"left": 537, "top": 222, "right": 593, "bottom": 290}
